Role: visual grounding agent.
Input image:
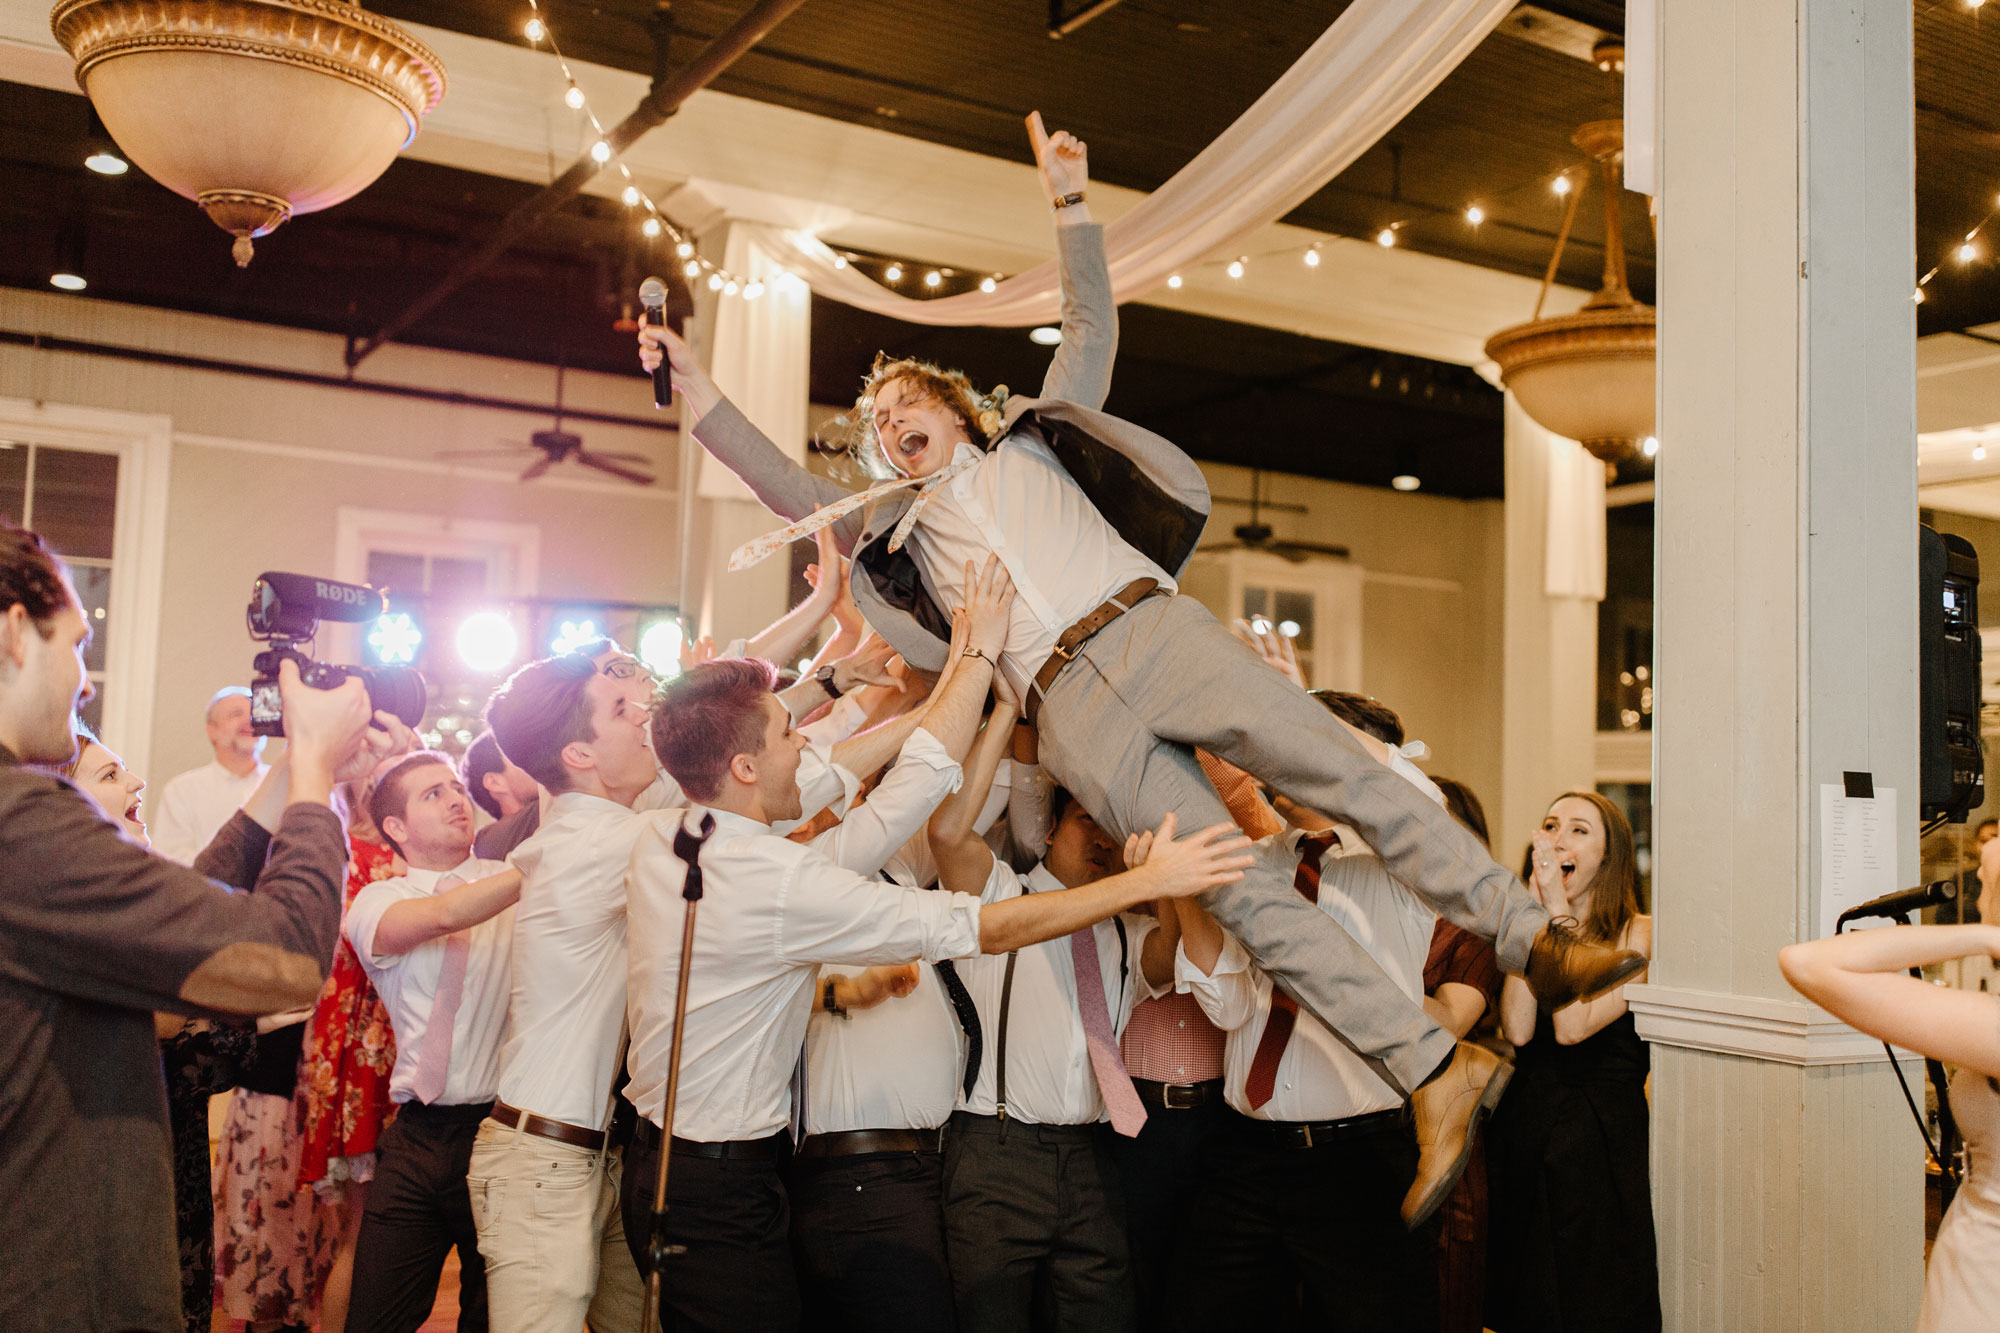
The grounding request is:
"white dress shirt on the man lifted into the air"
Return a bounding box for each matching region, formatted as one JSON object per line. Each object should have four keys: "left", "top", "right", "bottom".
{"left": 908, "top": 428, "right": 1174, "bottom": 699}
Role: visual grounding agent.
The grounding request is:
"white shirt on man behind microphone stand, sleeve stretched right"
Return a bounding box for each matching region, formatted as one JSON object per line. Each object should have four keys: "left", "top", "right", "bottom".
{"left": 626, "top": 807, "right": 980, "bottom": 1143}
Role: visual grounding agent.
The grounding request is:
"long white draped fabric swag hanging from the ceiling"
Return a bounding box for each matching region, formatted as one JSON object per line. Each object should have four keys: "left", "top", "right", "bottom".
{"left": 768, "top": 0, "right": 1514, "bottom": 326}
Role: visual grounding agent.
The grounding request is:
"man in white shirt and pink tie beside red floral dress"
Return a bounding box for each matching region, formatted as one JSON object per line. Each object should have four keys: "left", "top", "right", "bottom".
{"left": 342, "top": 751, "right": 520, "bottom": 1333}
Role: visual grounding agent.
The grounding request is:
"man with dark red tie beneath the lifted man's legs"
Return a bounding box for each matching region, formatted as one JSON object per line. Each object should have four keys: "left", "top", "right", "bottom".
{"left": 1168, "top": 831, "right": 1438, "bottom": 1333}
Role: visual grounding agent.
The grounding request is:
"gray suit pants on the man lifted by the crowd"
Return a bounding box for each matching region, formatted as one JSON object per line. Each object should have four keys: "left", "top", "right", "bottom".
{"left": 1040, "top": 596, "right": 1548, "bottom": 1089}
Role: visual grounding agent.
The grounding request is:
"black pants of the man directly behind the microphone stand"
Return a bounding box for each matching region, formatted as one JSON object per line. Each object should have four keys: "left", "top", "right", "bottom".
{"left": 620, "top": 1123, "right": 798, "bottom": 1333}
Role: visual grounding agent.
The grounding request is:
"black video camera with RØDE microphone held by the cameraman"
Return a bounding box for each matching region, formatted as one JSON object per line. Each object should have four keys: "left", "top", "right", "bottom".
{"left": 244, "top": 570, "right": 430, "bottom": 737}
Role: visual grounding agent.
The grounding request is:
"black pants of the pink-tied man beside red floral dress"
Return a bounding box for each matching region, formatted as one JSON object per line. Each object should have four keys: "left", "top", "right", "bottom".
{"left": 348, "top": 1101, "right": 492, "bottom": 1333}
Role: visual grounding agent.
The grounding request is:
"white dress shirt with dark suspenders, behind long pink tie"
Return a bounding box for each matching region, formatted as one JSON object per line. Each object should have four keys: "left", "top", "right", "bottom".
{"left": 958, "top": 861, "right": 1160, "bottom": 1125}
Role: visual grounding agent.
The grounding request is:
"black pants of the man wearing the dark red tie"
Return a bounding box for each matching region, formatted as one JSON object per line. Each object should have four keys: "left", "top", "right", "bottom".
{"left": 1168, "top": 1113, "right": 1438, "bottom": 1333}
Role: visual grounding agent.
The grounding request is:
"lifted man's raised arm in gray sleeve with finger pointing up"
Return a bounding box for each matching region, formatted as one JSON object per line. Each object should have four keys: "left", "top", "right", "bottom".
{"left": 1028, "top": 112, "right": 1118, "bottom": 408}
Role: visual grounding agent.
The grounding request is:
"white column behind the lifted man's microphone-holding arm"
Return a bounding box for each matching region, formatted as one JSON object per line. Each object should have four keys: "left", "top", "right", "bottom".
{"left": 684, "top": 220, "right": 812, "bottom": 644}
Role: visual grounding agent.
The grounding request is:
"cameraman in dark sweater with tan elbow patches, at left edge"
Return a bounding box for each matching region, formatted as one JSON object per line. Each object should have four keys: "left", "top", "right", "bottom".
{"left": 0, "top": 522, "right": 408, "bottom": 1333}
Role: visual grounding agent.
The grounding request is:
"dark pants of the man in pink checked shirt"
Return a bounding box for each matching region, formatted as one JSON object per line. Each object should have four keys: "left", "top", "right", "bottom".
{"left": 1110, "top": 1079, "right": 1234, "bottom": 1329}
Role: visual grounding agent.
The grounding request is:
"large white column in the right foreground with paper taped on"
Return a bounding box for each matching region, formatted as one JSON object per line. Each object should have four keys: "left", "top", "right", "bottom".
{"left": 1632, "top": 0, "right": 1924, "bottom": 1333}
